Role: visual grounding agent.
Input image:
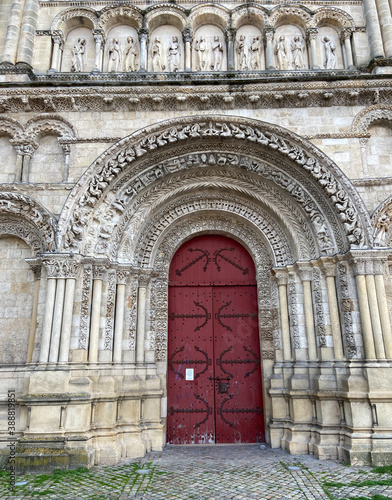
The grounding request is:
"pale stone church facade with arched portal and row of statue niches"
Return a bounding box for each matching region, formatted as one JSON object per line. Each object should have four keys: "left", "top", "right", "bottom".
{"left": 0, "top": 0, "right": 392, "bottom": 470}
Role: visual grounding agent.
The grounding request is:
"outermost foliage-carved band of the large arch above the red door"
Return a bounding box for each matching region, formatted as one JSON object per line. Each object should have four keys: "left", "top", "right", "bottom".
{"left": 61, "top": 117, "right": 366, "bottom": 248}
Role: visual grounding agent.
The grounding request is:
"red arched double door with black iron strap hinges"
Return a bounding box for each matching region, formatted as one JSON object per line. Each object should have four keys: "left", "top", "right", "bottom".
{"left": 167, "top": 234, "right": 264, "bottom": 444}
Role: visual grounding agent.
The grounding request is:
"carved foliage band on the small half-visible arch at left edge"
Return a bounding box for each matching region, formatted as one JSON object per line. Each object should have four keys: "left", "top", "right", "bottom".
{"left": 0, "top": 191, "right": 56, "bottom": 252}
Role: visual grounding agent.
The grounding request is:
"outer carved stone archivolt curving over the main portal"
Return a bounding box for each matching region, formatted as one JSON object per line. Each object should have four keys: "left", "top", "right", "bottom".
{"left": 59, "top": 117, "right": 371, "bottom": 258}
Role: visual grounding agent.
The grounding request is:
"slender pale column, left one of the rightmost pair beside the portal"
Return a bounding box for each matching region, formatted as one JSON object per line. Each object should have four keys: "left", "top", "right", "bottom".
{"left": 352, "top": 259, "right": 376, "bottom": 359}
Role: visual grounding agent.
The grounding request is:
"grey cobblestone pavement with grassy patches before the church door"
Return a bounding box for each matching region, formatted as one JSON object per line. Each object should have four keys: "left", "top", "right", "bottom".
{"left": 0, "top": 445, "right": 392, "bottom": 500}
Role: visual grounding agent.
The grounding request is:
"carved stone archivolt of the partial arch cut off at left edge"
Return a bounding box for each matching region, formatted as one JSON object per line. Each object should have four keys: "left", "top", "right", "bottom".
{"left": 0, "top": 191, "right": 57, "bottom": 254}
